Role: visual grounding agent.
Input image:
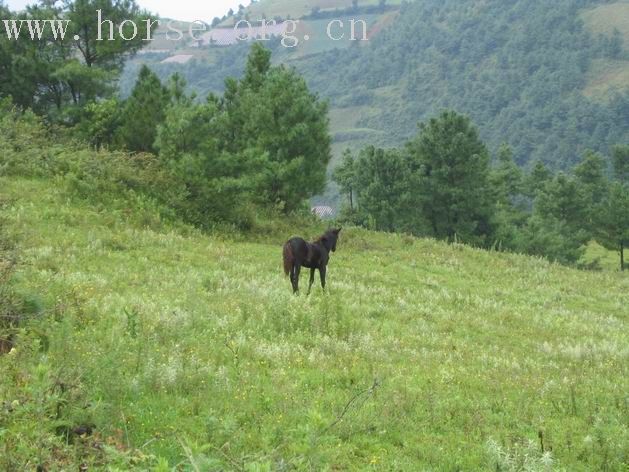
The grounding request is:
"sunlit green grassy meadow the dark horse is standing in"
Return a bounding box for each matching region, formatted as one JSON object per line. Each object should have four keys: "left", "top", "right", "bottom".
{"left": 0, "top": 177, "right": 629, "bottom": 471}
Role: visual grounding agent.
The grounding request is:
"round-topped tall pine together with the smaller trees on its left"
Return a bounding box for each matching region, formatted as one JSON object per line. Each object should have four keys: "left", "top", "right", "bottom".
{"left": 334, "top": 112, "right": 496, "bottom": 245}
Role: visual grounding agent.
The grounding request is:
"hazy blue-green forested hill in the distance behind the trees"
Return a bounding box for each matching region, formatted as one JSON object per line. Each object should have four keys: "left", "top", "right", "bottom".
{"left": 121, "top": 0, "right": 629, "bottom": 168}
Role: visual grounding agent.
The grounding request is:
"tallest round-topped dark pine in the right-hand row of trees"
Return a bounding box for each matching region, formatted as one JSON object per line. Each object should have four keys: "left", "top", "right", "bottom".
{"left": 408, "top": 111, "right": 495, "bottom": 244}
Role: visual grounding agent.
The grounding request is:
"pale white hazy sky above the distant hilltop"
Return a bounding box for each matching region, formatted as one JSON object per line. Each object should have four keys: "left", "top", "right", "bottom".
{"left": 4, "top": 0, "right": 249, "bottom": 23}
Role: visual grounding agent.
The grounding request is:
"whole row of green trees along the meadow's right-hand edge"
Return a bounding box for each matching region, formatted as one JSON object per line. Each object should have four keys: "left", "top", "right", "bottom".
{"left": 333, "top": 111, "right": 629, "bottom": 270}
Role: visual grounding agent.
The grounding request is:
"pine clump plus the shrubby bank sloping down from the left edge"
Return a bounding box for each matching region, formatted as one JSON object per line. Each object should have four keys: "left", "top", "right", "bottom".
{"left": 0, "top": 46, "right": 330, "bottom": 229}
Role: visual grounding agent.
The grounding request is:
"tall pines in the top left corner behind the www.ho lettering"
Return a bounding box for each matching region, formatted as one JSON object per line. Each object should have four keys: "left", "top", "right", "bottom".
{"left": 0, "top": 0, "right": 147, "bottom": 117}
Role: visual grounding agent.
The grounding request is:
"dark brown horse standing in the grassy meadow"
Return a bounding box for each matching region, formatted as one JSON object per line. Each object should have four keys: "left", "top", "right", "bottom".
{"left": 283, "top": 228, "right": 341, "bottom": 293}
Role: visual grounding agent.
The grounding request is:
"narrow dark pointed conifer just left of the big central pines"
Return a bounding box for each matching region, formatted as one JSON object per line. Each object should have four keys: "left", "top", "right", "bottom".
{"left": 117, "top": 66, "right": 170, "bottom": 152}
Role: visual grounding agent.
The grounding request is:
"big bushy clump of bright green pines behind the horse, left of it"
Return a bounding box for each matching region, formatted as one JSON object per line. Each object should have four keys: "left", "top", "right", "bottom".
{"left": 156, "top": 44, "right": 330, "bottom": 223}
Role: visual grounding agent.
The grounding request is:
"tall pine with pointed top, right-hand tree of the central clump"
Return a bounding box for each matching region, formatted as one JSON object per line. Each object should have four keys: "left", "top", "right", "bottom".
{"left": 222, "top": 43, "right": 331, "bottom": 211}
